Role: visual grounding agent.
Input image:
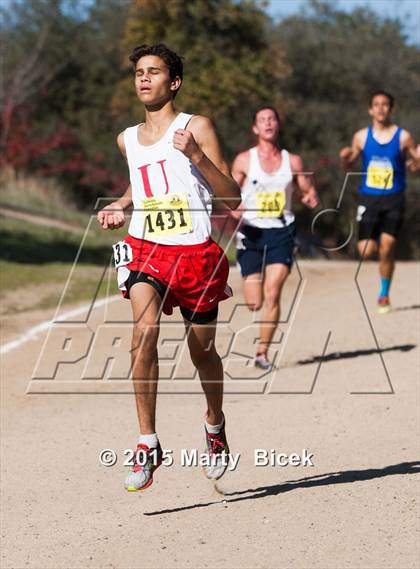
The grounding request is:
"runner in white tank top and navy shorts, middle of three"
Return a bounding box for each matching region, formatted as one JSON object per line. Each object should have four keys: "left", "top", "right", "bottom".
{"left": 232, "top": 107, "right": 317, "bottom": 370}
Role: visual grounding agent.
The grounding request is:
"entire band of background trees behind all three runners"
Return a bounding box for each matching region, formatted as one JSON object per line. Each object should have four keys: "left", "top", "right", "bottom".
{"left": 0, "top": 0, "right": 420, "bottom": 257}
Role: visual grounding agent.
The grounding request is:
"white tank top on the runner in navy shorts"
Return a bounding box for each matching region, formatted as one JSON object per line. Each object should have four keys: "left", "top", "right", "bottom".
{"left": 242, "top": 146, "right": 295, "bottom": 229}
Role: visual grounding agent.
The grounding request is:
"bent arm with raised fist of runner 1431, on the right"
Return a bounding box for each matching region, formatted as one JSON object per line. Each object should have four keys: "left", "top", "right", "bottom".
{"left": 174, "top": 115, "right": 241, "bottom": 209}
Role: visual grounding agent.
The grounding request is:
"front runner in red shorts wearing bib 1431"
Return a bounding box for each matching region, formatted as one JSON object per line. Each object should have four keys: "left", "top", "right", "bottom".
{"left": 98, "top": 44, "right": 240, "bottom": 491}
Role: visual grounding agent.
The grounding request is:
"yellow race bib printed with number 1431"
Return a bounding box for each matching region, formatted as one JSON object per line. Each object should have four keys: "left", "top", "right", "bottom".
{"left": 143, "top": 192, "right": 193, "bottom": 235}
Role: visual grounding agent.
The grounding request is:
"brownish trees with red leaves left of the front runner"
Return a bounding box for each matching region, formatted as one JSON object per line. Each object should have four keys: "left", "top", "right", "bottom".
{"left": 0, "top": 0, "right": 127, "bottom": 205}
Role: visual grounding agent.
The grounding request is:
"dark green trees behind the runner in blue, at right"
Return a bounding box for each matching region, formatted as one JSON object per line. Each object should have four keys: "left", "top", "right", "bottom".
{"left": 270, "top": 1, "right": 420, "bottom": 258}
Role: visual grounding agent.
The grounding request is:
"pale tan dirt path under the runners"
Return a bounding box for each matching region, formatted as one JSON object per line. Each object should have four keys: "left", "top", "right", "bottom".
{"left": 1, "top": 262, "right": 420, "bottom": 569}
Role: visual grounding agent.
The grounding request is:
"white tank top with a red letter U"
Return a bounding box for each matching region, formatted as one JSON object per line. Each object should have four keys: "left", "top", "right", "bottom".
{"left": 124, "top": 113, "right": 213, "bottom": 245}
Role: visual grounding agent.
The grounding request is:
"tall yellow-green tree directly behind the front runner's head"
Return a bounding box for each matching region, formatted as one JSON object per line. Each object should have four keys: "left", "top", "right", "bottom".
{"left": 113, "top": 0, "right": 289, "bottom": 158}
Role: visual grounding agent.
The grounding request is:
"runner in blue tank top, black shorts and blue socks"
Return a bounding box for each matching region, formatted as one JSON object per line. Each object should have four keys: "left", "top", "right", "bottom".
{"left": 340, "top": 91, "right": 420, "bottom": 313}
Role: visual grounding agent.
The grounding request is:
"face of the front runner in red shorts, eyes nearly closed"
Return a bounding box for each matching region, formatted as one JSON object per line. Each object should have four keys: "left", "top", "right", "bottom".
{"left": 135, "top": 55, "right": 181, "bottom": 105}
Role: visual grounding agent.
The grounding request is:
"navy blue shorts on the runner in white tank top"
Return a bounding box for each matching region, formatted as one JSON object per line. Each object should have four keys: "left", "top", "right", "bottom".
{"left": 236, "top": 223, "right": 296, "bottom": 277}
